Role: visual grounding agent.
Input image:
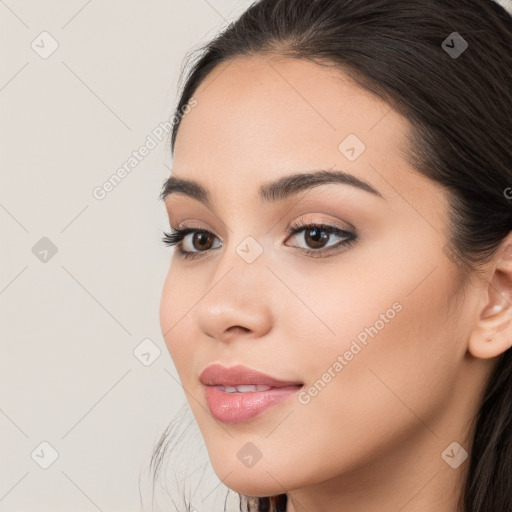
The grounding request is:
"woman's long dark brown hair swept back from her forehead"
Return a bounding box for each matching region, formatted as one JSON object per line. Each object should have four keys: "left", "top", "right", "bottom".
{"left": 154, "top": 0, "right": 512, "bottom": 512}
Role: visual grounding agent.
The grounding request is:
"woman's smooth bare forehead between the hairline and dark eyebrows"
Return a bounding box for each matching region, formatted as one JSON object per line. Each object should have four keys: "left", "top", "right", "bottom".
{"left": 173, "top": 57, "right": 416, "bottom": 202}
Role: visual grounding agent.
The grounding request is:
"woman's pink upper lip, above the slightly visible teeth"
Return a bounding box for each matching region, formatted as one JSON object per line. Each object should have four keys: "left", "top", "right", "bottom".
{"left": 199, "top": 364, "right": 302, "bottom": 388}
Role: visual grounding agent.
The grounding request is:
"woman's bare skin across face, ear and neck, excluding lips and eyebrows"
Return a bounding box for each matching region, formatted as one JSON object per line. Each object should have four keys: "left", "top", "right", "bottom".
{"left": 160, "top": 57, "right": 512, "bottom": 512}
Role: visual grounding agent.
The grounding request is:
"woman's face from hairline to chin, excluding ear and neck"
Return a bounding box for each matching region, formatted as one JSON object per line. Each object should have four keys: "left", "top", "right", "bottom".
{"left": 160, "top": 57, "right": 480, "bottom": 496}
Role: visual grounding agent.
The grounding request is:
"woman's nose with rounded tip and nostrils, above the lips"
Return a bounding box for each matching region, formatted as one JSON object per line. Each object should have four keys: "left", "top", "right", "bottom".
{"left": 196, "top": 258, "right": 275, "bottom": 342}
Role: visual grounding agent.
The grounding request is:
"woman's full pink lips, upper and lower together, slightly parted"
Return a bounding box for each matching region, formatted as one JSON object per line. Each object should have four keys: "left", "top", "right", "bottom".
{"left": 199, "top": 364, "right": 302, "bottom": 423}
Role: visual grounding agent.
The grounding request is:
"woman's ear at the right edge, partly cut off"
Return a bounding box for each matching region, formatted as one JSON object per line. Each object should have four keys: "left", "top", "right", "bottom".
{"left": 468, "top": 237, "right": 512, "bottom": 359}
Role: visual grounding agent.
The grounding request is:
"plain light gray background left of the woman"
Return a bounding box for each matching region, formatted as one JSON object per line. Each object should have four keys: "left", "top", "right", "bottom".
{"left": 0, "top": 0, "right": 252, "bottom": 512}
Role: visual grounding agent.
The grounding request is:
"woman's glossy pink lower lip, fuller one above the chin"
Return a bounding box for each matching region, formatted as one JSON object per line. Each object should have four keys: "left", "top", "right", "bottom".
{"left": 205, "top": 386, "right": 302, "bottom": 423}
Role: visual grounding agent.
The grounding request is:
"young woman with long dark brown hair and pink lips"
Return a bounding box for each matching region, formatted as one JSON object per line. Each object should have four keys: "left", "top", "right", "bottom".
{"left": 153, "top": 0, "right": 512, "bottom": 512}
